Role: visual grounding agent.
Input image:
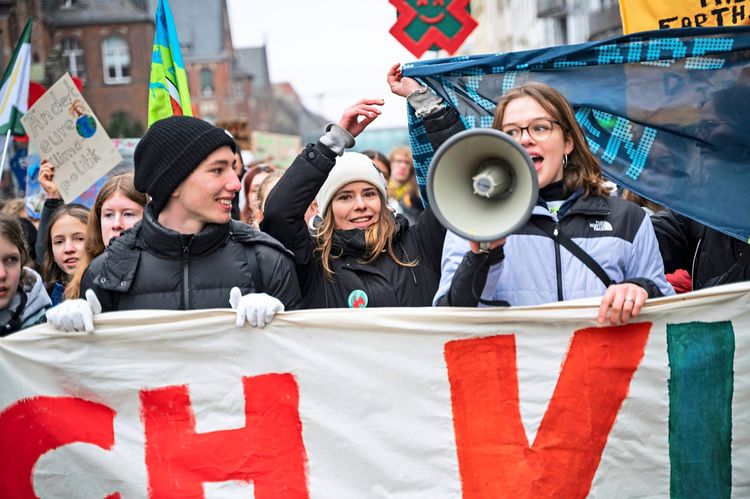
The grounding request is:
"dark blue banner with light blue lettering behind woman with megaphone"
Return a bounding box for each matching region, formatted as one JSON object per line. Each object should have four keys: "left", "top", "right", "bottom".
{"left": 404, "top": 26, "right": 750, "bottom": 241}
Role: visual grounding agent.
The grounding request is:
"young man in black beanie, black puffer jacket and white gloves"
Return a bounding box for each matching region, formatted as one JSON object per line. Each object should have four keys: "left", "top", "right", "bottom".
{"left": 48, "top": 116, "right": 302, "bottom": 331}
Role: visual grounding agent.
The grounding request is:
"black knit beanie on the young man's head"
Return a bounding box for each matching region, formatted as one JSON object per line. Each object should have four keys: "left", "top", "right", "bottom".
{"left": 134, "top": 116, "right": 237, "bottom": 213}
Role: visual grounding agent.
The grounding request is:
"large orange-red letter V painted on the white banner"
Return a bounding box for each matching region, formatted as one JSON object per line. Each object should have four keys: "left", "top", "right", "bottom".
{"left": 445, "top": 323, "right": 651, "bottom": 499}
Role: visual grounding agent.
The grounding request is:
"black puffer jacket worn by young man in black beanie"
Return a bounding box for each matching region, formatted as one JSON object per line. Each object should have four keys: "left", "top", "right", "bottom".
{"left": 81, "top": 205, "right": 302, "bottom": 312}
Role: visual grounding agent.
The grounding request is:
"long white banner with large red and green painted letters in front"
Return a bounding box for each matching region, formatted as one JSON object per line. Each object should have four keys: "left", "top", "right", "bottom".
{"left": 0, "top": 284, "right": 750, "bottom": 499}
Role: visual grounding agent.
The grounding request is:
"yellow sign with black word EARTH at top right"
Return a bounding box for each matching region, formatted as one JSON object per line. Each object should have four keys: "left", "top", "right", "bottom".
{"left": 620, "top": 0, "right": 750, "bottom": 34}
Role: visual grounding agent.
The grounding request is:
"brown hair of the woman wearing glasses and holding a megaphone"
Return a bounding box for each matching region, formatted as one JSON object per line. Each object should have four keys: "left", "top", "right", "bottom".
{"left": 492, "top": 81, "right": 609, "bottom": 196}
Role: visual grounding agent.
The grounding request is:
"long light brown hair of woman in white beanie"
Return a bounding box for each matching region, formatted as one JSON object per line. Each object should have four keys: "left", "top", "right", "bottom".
{"left": 315, "top": 190, "right": 419, "bottom": 281}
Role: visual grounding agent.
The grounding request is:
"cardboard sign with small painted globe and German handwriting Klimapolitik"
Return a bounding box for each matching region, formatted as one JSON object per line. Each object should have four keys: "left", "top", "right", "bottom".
{"left": 21, "top": 73, "right": 122, "bottom": 203}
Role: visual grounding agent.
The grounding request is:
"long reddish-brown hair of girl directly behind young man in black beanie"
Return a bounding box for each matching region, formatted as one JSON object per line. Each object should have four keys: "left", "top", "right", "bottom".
{"left": 65, "top": 172, "right": 148, "bottom": 299}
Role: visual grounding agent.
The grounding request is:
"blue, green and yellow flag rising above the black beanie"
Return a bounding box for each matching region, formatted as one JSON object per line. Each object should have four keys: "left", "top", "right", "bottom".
{"left": 148, "top": 0, "right": 193, "bottom": 126}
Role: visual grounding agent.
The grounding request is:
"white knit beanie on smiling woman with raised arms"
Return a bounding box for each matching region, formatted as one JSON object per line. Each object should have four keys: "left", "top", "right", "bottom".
{"left": 316, "top": 152, "right": 388, "bottom": 216}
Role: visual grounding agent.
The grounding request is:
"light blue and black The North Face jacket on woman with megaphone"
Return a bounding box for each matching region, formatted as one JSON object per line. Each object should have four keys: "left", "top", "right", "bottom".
{"left": 433, "top": 192, "right": 674, "bottom": 306}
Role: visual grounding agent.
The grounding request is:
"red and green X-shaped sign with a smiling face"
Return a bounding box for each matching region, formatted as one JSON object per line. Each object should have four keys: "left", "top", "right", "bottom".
{"left": 389, "top": 0, "right": 477, "bottom": 57}
